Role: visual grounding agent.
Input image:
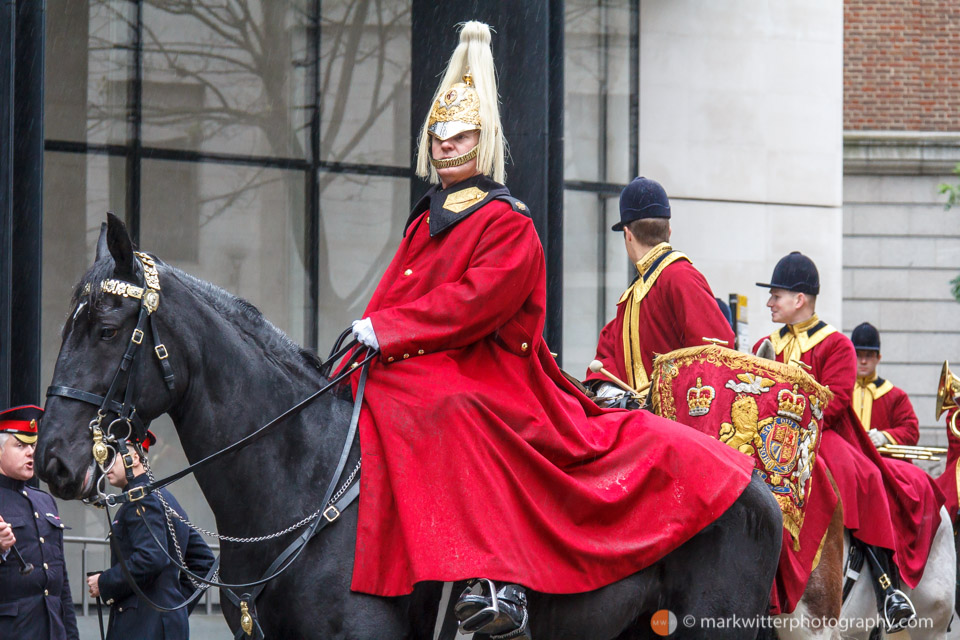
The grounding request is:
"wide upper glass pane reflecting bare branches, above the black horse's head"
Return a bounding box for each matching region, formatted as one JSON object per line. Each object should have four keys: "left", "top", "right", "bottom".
{"left": 143, "top": 0, "right": 311, "bottom": 158}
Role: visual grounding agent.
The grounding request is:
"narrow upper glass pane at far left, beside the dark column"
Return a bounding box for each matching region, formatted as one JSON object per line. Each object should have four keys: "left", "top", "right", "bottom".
{"left": 44, "top": 0, "right": 135, "bottom": 144}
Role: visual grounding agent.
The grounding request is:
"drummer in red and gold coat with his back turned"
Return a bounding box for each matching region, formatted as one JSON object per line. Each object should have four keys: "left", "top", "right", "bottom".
{"left": 587, "top": 177, "right": 734, "bottom": 391}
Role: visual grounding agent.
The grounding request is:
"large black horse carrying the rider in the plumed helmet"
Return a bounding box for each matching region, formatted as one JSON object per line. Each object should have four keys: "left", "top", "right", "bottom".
{"left": 36, "top": 216, "right": 782, "bottom": 640}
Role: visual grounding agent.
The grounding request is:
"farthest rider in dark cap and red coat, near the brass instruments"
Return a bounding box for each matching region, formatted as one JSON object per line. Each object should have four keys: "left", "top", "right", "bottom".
{"left": 850, "top": 322, "right": 920, "bottom": 447}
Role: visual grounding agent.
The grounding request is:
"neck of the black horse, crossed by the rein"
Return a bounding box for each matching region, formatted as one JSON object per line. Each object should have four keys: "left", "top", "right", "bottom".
{"left": 170, "top": 282, "right": 343, "bottom": 535}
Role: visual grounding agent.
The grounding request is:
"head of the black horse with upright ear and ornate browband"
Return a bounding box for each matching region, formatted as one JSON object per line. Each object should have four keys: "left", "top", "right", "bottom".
{"left": 36, "top": 214, "right": 179, "bottom": 499}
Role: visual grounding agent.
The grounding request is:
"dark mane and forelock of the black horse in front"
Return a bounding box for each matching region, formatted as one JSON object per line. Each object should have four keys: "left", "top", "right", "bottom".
{"left": 71, "top": 255, "right": 322, "bottom": 369}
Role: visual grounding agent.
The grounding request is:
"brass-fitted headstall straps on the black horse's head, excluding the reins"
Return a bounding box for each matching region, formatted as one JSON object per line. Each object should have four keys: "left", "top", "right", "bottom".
{"left": 47, "top": 251, "right": 174, "bottom": 484}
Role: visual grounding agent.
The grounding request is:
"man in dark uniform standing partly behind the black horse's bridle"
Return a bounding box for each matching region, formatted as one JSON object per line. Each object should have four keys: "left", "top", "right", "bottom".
{"left": 87, "top": 431, "right": 214, "bottom": 640}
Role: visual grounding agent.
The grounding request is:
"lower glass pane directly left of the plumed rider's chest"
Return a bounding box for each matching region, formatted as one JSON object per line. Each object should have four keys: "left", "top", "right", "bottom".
{"left": 319, "top": 174, "right": 410, "bottom": 348}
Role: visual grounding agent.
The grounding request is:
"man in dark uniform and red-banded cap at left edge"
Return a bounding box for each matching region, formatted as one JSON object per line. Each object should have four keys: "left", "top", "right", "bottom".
{"left": 0, "top": 406, "right": 80, "bottom": 640}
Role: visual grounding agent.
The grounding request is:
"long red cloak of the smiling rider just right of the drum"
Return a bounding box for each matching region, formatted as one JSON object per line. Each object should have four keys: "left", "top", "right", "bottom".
{"left": 753, "top": 325, "right": 943, "bottom": 589}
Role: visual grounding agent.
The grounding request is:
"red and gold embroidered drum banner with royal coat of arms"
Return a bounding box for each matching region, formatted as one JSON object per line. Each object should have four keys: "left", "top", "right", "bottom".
{"left": 651, "top": 345, "right": 833, "bottom": 549}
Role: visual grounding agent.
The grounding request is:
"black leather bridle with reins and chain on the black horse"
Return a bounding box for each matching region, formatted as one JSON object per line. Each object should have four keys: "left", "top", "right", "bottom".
{"left": 47, "top": 252, "right": 379, "bottom": 639}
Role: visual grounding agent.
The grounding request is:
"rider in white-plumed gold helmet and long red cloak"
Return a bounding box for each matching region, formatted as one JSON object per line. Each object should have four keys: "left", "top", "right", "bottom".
{"left": 344, "top": 22, "right": 752, "bottom": 637}
